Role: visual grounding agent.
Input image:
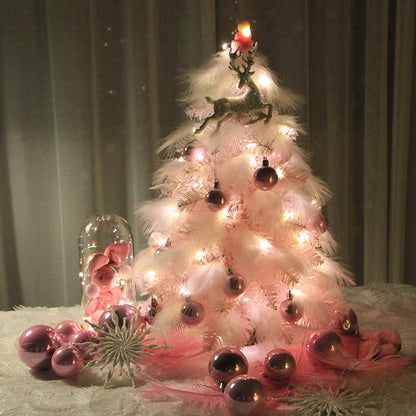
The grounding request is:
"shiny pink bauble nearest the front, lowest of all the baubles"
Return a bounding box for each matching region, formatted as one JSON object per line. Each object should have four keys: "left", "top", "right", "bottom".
{"left": 224, "top": 375, "right": 267, "bottom": 416}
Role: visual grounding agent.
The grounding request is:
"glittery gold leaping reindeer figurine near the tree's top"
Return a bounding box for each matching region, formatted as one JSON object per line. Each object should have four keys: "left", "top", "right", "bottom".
{"left": 194, "top": 44, "right": 273, "bottom": 134}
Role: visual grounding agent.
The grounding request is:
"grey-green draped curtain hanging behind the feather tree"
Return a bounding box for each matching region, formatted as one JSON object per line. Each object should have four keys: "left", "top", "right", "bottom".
{"left": 0, "top": 0, "right": 416, "bottom": 309}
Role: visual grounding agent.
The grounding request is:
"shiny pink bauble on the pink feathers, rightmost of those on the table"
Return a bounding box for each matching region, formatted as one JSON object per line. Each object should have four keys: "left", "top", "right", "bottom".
{"left": 306, "top": 329, "right": 344, "bottom": 363}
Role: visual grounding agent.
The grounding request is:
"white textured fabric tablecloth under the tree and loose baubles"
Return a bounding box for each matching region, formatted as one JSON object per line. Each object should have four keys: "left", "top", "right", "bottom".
{"left": 0, "top": 285, "right": 416, "bottom": 416}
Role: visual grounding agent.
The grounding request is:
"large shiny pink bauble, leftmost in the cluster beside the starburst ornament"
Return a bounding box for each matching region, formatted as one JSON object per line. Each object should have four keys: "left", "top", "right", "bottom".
{"left": 18, "top": 325, "right": 62, "bottom": 370}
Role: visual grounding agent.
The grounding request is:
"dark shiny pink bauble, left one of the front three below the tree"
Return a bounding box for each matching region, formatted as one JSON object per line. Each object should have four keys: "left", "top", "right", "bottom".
{"left": 208, "top": 347, "right": 248, "bottom": 389}
